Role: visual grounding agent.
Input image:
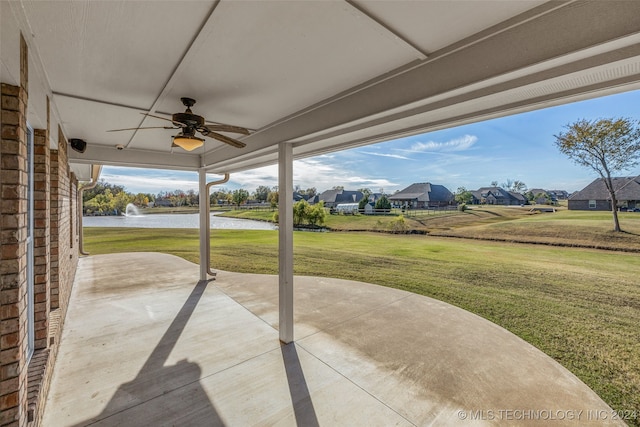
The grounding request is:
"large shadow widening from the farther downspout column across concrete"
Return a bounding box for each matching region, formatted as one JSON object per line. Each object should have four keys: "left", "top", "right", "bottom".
{"left": 70, "top": 280, "right": 225, "bottom": 427}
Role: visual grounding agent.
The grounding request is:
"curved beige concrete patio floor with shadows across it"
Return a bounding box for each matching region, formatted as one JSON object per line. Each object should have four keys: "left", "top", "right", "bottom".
{"left": 43, "top": 253, "right": 615, "bottom": 427}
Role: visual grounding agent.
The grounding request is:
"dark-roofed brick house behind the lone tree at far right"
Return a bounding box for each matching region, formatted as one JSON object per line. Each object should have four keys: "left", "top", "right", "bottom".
{"left": 568, "top": 176, "right": 640, "bottom": 211}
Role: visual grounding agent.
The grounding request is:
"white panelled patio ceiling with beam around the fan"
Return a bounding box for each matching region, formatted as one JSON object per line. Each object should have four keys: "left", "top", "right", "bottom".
{"left": 0, "top": 0, "right": 640, "bottom": 179}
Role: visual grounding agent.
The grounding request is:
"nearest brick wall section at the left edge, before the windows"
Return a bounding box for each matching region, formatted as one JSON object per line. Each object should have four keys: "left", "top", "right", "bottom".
{"left": 0, "top": 38, "right": 28, "bottom": 427}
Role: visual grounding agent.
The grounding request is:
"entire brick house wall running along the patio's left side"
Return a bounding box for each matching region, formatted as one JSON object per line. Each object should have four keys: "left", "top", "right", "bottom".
{"left": 0, "top": 31, "right": 78, "bottom": 427}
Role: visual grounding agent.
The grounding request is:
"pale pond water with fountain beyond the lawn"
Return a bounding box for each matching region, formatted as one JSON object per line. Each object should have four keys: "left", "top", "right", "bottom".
{"left": 82, "top": 213, "right": 278, "bottom": 230}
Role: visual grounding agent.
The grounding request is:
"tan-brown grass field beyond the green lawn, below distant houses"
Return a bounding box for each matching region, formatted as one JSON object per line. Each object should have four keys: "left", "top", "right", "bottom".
{"left": 223, "top": 206, "right": 640, "bottom": 252}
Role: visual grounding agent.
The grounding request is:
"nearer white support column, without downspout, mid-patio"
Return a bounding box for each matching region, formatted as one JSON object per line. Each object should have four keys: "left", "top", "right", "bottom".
{"left": 278, "top": 143, "right": 293, "bottom": 344}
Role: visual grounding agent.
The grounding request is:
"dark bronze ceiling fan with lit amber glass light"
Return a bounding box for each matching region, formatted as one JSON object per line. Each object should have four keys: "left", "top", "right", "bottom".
{"left": 107, "top": 98, "right": 249, "bottom": 151}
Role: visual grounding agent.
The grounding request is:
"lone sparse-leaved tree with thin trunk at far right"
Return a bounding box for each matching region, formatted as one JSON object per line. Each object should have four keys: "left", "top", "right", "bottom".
{"left": 554, "top": 118, "right": 640, "bottom": 232}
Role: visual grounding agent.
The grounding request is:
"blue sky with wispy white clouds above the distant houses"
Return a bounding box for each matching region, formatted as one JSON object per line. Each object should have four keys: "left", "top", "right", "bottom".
{"left": 101, "top": 91, "right": 640, "bottom": 194}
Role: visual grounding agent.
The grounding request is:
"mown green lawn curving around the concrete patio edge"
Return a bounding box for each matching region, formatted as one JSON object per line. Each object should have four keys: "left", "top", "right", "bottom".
{"left": 85, "top": 226, "right": 640, "bottom": 425}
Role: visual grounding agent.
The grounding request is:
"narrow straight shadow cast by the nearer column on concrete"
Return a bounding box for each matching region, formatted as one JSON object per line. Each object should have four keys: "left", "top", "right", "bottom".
{"left": 280, "top": 343, "right": 320, "bottom": 427}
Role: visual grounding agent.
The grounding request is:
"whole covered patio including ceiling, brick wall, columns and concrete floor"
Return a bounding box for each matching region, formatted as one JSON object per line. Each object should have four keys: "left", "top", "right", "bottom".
{"left": 0, "top": 0, "right": 640, "bottom": 427}
